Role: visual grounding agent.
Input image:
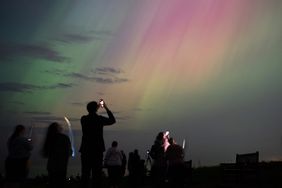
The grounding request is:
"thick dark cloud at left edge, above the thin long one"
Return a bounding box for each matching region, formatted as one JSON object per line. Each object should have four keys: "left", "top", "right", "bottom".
{"left": 0, "top": 44, "right": 67, "bottom": 62}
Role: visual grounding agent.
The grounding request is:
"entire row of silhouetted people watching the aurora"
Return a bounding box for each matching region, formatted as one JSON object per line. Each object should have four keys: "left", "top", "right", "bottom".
{"left": 5, "top": 101, "right": 187, "bottom": 188}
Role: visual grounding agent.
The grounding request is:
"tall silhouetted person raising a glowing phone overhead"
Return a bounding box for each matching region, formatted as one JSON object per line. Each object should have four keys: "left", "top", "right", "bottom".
{"left": 79, "top": 101, "right": 116, "bottom": 188}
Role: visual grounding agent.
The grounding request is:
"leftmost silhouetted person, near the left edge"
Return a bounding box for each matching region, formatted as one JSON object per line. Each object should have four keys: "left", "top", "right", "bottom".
{"left": 5, "top": 125, "right": 33, "bottom": 182}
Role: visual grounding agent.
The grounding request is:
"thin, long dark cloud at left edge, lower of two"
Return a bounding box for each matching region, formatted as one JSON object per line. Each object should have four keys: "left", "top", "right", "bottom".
{"left": 0, "top": 82, "right": 73, "bottom": 92}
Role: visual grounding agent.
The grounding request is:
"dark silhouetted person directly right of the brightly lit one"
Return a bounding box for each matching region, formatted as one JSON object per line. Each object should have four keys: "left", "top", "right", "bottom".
{"left": 165, "top": 138, "right": 185, "bottom": 188}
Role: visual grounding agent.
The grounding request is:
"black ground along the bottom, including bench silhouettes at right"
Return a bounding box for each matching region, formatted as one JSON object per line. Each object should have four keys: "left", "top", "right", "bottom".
{"left": 0, "top": 162, "right": 282, "bottom": 188}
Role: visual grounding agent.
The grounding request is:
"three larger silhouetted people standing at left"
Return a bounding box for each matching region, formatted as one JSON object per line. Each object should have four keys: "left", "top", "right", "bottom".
{"left": 5, "top": 101, "right": 117, "bottom": 188}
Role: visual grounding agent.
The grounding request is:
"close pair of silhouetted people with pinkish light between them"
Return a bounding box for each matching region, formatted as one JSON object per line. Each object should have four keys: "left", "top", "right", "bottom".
{"left": 149, "top": 131, "right": 185, "bottom": 187}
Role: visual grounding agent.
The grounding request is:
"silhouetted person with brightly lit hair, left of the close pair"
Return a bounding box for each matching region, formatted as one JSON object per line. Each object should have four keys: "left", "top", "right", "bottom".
{"left": 150, "top": 132, "right": 168, "bottom": 187}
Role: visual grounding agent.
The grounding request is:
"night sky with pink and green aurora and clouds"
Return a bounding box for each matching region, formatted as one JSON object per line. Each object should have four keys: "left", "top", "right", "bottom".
{"left": 0, "top": 0, "right": 282, "bottom": 175}
